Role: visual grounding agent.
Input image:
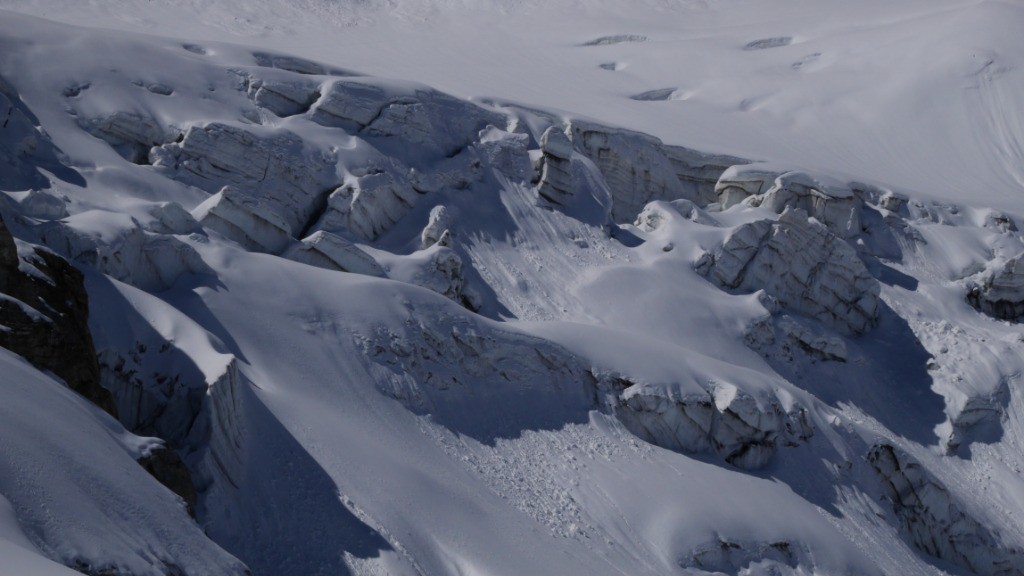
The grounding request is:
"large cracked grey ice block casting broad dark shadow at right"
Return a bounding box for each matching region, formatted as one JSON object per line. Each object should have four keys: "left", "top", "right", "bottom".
{"left": 696, "top": 209, "right": 881, "bottom": 334}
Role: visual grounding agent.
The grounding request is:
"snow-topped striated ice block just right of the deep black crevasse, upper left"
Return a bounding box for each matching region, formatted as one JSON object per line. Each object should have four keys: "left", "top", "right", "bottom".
{"left": 316, "top": 161, "right": 420, "bottom": 240}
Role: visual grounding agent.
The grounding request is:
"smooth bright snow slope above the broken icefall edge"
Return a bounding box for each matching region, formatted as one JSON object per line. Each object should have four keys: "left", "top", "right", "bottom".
{"left": 0, "top": 0, "right": 1024, "bottom": 210}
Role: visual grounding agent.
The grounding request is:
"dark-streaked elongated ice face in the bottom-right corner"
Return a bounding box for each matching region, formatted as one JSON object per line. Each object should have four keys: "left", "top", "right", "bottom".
{"left": 867, "top": 444, "right": 1024, "bottom": 576}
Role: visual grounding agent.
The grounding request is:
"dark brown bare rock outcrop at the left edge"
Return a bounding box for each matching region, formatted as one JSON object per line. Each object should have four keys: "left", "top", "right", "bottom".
{"left": 0, "top": 211, "right": 116, "bottom": 414}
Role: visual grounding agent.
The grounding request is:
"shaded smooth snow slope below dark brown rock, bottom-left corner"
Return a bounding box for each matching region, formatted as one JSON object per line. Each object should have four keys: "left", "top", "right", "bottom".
{"left": 0, "top": 344, "right": 240, "bottom": 575}
